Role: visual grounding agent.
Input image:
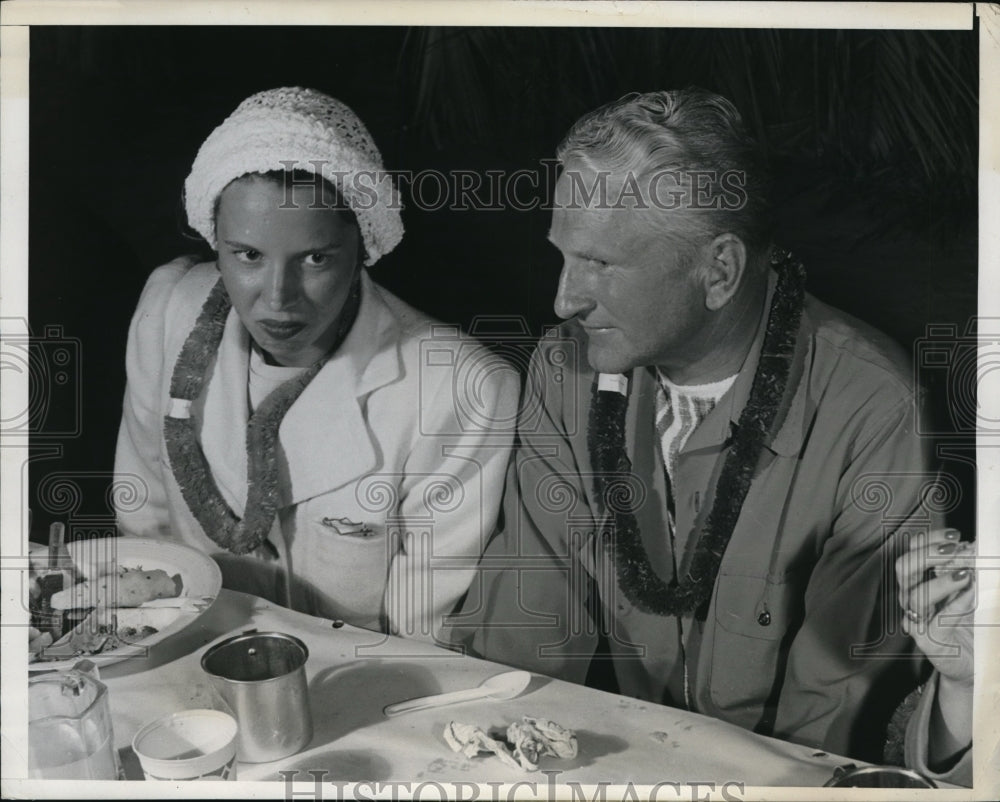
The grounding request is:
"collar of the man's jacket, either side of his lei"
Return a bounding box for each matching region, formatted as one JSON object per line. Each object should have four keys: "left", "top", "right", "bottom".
{"left": 641, "top": 270, "right": 812, "bottom": 456}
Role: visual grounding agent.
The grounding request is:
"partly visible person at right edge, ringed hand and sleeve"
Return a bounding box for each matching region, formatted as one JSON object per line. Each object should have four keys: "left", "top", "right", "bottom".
{"left": 896, "top": 529, "right": 976, "bottom": 786}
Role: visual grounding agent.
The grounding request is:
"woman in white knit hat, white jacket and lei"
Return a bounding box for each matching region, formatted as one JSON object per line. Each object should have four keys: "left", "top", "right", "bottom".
{"left": 115, "top": 88, "right": 518, "bottom": 639}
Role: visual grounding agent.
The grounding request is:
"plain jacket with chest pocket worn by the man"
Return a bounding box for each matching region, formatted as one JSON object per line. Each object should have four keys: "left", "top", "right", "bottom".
{"left": 460, "top": 266, "right": 938, "bottom": 759}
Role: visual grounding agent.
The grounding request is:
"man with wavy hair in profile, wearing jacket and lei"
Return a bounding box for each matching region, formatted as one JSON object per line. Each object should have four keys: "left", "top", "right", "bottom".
{"left": 454, "top": 90, "right": 931, "bottom": 759}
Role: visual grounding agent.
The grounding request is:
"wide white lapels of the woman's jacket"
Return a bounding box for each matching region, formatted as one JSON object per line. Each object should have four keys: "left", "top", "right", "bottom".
{"left": 195, "top": 271, "right": 403, "bottom": 512}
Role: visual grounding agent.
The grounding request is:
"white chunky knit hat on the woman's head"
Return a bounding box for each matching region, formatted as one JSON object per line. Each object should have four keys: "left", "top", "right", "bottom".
{"left": 184, "top": 87, "right": 403, "bottom": 265}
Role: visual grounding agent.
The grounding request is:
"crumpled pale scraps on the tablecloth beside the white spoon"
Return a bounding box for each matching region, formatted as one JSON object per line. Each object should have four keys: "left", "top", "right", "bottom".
{"left": 444, "top": 716, "right": 577, "bottom": 771}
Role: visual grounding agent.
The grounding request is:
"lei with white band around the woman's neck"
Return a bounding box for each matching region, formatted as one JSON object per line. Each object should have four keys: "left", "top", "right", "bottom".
{"left": 163, "top": 274, "right": 361, "bottom": 554}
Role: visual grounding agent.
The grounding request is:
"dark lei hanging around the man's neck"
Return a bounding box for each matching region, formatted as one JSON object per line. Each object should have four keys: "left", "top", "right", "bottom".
{"left": 587, "top": 252, "right": 805, "bottom": 620}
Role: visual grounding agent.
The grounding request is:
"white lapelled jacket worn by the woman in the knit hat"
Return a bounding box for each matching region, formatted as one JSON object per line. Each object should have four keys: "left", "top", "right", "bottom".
{"left": 114, "top": 259, "right": 519, "bottom": 640}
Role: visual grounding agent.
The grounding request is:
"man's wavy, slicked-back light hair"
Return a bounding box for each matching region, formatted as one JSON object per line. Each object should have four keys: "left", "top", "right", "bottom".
{"left": 556, "top": 87, "right": 773, "bottom": 264}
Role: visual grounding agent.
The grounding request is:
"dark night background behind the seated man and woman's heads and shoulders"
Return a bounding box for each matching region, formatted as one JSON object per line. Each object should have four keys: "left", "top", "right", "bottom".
{"left": 29, "top": 27, "right": 978, "bottom": 540}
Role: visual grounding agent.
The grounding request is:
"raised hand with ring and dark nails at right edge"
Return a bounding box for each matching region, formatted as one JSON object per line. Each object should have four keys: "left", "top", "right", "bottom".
{"left": 896, "top": 529, "right": 976, "bottom": 688}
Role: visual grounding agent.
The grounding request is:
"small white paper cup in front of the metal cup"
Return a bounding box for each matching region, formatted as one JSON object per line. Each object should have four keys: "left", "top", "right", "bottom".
{"left": 132, "top": 710, "right": 239, "bottom": 781}
